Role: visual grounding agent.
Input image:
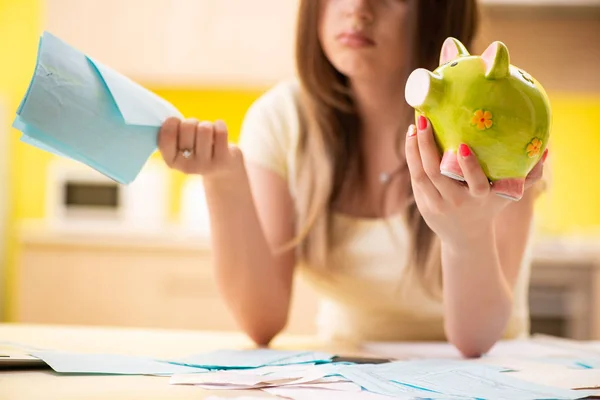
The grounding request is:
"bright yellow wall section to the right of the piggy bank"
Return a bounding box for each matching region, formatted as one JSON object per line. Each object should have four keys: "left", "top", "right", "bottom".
{"left": 537, "top": 93, "right": 600, "bottom": 234}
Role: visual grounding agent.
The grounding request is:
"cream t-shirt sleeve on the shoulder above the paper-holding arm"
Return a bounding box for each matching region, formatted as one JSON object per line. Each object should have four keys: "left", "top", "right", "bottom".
{"left": 238, "top": 84, "right": 297, "bottom": 180}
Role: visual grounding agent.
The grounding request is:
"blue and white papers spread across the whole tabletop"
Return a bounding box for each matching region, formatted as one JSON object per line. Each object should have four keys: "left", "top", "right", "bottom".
{"left": 22, "top": 345, "right": 600, "bottom": 400}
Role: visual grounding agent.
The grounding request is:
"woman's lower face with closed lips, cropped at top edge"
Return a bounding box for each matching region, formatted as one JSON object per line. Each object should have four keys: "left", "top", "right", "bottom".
{"left": 319, "top": 0, "right": 407, "bottom": 79}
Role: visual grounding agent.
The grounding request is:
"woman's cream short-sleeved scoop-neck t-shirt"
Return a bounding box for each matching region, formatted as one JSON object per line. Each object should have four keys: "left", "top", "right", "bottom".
{"left": 239, "top": 81, "right": 530, "bottom": 341}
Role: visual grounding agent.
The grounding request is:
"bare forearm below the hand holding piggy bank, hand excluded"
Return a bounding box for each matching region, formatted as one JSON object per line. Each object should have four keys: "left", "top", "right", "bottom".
{"left": 442, "top": 191, "right": 535, "bottom": 357}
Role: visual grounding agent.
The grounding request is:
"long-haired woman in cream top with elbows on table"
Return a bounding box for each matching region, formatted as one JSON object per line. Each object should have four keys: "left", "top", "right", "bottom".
{"left": 159, "top": 0, "right": 541, "bottom": 356}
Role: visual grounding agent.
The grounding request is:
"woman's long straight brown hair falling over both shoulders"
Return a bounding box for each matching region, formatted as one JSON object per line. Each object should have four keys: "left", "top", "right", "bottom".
{"left": 296, "top": 0, "right": 478, "bottom": 294}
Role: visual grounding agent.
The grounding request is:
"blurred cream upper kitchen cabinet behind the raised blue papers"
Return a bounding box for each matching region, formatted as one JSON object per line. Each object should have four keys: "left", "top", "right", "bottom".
{"left": 45, "top": 0, "right": 298, "bottom": 87}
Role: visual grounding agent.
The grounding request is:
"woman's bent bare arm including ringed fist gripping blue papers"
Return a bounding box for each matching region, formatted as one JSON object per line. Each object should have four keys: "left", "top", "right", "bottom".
{"left": 159, "top": 119, "right": 294, "bottom": 345}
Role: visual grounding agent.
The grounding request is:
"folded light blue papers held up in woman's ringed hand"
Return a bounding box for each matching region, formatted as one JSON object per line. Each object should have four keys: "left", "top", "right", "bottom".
{"left": 13, "top": 32, "right": 182, "bottom": 184}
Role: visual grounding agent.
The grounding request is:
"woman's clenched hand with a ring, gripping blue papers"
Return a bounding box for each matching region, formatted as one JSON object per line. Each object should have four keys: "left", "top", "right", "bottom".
{"left": 158, "top": 117, "right": 243, "bottom": 178}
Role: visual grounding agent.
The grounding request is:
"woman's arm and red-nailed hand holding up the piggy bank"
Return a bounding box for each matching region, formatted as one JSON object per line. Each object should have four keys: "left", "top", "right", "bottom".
{"left": 405, "top": 117, "right": 547, "bottom": 357}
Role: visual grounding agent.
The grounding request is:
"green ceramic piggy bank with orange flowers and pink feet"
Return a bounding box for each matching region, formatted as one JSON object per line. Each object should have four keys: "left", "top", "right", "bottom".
{"left": 405, "top": 38, "right": 551, "bottom": 200}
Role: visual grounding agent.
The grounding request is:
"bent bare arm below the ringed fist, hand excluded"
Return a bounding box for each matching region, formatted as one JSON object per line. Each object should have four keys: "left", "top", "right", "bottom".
{"left": 205, "top": 161, "right": 294, "bottom": 345}
